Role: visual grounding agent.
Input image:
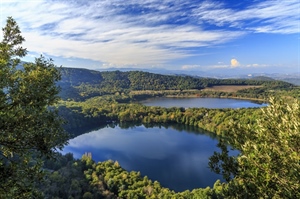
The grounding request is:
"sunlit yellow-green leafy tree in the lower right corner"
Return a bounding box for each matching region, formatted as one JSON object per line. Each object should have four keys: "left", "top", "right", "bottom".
{"left": 210, "top": 98, "right": 300, "bottom": 198}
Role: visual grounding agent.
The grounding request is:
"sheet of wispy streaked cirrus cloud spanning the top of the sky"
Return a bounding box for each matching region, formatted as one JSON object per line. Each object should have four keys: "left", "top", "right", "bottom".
{"left": 1, "top": 0, "right": 299, "bottom": 68}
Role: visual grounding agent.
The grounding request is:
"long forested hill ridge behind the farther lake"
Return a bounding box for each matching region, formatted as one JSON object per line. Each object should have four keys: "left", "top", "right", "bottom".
{"left": 58, "top": 68, "right": 292, "bottom": 99}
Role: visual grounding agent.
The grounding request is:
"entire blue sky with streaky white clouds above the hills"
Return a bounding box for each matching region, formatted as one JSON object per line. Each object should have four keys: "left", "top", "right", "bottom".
{"left": 0, "top": 0, "right": 300, "bottom": 74}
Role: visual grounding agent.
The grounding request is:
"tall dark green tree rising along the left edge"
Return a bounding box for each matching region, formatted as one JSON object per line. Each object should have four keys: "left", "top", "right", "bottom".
{"left": 0, "top": 17, "right": 68, "bottom": 198}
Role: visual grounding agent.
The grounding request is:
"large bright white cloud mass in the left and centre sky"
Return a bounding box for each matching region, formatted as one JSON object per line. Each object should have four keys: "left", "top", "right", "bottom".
{"left": 2, "top": 1, "right": 243, "bottom": 65}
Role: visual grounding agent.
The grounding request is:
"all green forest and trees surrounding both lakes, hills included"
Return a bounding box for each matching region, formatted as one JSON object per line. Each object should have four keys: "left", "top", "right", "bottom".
{"left": 0, "top": 17, "right": 300, "bottom": 199}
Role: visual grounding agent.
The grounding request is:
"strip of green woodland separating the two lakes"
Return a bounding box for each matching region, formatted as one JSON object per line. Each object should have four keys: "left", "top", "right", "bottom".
{"left": 59, "top": 96, "right": 259, "bottom": 135}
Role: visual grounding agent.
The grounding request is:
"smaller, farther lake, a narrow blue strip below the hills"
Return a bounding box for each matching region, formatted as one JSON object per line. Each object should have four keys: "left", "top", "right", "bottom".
{"left": 140, "top": 97, "right": 267, "bottom": 108}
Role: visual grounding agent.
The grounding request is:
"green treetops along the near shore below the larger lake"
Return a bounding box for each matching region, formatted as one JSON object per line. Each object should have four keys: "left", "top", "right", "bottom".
{"left": 39, "top": 154, "right": 222, "bottom": 199}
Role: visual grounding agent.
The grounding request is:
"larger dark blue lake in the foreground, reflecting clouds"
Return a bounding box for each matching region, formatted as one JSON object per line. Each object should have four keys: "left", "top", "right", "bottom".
{"left": 63, "top": 125, "right": 237, "bottom": 191}
